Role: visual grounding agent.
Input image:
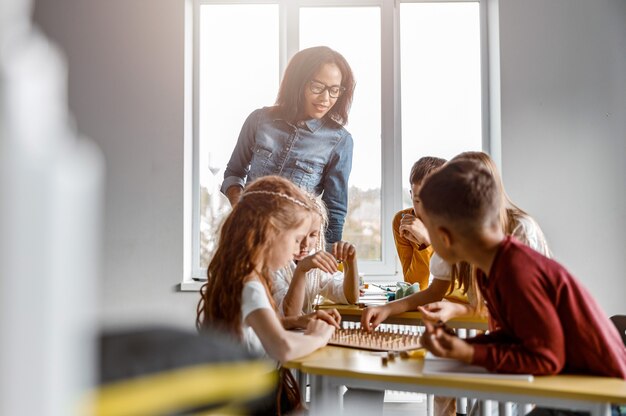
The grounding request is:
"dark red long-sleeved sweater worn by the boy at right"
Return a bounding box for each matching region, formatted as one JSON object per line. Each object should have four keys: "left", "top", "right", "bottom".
{"left": 468, "top": 237, "right": 626, "bottom": 379}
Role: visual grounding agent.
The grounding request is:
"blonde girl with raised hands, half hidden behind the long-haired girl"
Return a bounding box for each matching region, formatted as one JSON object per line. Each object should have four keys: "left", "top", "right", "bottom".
{"left": 273, "top": 195, "right": 359, "bottom": 317}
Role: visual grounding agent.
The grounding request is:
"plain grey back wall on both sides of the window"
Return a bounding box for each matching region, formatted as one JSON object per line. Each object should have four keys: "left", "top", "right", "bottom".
{"left": 35, "top": 0, "right": 626, "bottom": 326}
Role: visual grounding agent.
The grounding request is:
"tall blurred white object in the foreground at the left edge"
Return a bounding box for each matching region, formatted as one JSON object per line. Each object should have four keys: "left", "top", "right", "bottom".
{"left": 0, "top": 0, "right": 104, "bottom": 416}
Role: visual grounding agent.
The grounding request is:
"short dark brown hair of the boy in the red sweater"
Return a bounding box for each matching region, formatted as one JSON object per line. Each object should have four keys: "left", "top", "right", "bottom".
{"left": 419, "top": 160, "right": 502, "bottom": 235}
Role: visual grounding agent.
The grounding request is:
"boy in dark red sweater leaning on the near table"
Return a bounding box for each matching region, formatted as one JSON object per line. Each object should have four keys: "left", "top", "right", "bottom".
{"left": 419, "top": 161, "right": 626, "bottom": 379}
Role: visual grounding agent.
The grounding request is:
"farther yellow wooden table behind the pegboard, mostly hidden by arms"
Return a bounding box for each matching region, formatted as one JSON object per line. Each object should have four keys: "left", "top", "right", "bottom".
{"left": 318, "top": 304, "right": 488, "bottom": 330}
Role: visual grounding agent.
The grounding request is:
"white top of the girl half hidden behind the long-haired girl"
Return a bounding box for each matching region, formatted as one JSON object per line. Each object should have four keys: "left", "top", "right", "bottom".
{"left": 272, "top": 261, "right": 348, "bottom": 315}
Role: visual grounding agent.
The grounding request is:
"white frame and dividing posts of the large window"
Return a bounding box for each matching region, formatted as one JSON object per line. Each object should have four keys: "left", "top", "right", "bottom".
{"left": 181, "top": 0, "right": 501, "bottom": 289}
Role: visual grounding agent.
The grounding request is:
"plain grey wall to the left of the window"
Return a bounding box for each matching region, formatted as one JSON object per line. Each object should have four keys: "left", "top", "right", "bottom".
{"left": 35, "top": 0, "right": 198, "bottom": 327}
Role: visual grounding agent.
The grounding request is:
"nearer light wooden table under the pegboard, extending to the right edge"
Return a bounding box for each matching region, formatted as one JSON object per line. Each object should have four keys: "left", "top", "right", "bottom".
{"left": 285, "top": 346, "right": 626, "bottom": 416}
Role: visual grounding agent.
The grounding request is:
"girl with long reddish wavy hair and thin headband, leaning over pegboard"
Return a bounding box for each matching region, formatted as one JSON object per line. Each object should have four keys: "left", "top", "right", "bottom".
{"left": 196, "top": 176, "right": 336, "bottom": 362}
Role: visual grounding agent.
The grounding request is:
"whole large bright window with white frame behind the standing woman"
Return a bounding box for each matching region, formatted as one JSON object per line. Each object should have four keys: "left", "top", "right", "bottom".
{"left": 186, "top": 0, "right": 489, "bottom": 280}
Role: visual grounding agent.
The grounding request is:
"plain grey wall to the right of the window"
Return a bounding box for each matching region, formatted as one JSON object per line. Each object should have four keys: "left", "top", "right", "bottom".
{"left": 500, "top": 0, "right": 626, "bottom": 315}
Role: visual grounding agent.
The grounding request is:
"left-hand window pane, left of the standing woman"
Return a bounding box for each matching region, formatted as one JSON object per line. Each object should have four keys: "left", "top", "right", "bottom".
{"left": 194, "top": 4, "right": 279, "bottom": 274}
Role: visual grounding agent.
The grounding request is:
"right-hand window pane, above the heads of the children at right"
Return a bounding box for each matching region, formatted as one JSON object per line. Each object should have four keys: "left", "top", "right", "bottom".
{"left": 400, "top": 2, "right": 482, "bottom": 207}
